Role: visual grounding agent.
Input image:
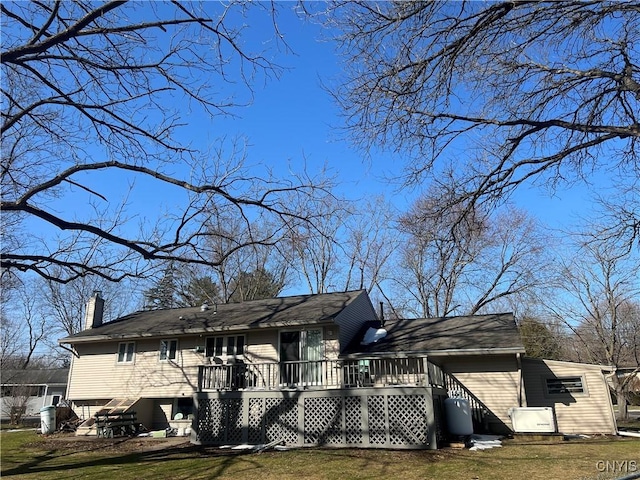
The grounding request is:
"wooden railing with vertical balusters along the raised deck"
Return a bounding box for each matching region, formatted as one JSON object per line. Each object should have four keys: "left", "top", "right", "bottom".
{"left": 198, "top": 357, "right": 444, "bottom": 391}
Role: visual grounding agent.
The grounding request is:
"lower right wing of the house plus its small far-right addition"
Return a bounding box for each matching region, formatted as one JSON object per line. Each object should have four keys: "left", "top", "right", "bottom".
{"left": 345, "top": 313, "right": 617, "bottom": 435}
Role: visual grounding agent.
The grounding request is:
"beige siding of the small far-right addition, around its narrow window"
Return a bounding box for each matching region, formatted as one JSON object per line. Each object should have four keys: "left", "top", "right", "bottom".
{"left": 522, "top": 359, "right": 616, "bottom": 434}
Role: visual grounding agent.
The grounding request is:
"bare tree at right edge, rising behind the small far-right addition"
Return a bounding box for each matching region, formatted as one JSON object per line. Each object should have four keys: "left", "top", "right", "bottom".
{"left": 547, "top": 232, "right": 640, "bottom": 418}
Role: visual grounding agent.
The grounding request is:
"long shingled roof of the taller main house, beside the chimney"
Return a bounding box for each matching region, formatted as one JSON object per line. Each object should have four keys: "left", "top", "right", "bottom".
{"left": 58, "top": 290, "right": 367, "bottom": 344}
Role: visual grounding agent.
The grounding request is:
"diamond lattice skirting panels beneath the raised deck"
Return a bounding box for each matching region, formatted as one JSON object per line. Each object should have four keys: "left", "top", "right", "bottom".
{"left": 192, "top": 387, "right": 444, "bottom": 448}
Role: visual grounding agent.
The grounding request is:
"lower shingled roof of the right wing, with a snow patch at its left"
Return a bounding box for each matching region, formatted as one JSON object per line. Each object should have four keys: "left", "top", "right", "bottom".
{"left": 345, "top": 313, "right": 524, "bottom": 355}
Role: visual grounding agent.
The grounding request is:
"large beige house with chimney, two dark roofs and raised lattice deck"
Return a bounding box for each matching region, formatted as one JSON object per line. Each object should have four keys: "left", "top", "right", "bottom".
{"left": 60, "top": 290, "right": 610, "bottom": 448}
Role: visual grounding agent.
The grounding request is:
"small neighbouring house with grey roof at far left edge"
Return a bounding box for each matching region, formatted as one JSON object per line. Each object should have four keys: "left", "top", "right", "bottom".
{"left": 0, "top": 368, "right": 69, "bottom": 419}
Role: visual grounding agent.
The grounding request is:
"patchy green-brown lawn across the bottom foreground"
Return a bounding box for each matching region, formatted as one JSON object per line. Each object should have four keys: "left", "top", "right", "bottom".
{"left": 0, "top": 432, "right": 640, "bottom": 480}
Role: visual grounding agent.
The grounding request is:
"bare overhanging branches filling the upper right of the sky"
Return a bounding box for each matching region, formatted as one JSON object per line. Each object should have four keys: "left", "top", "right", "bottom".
{"left": 329, "top": 0, "right": 640, "bottom": 248}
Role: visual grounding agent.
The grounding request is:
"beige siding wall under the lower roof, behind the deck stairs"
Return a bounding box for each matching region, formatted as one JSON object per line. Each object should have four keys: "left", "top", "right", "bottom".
{"left": 434, "top": 355, "right": 520, "bottom": 433}
